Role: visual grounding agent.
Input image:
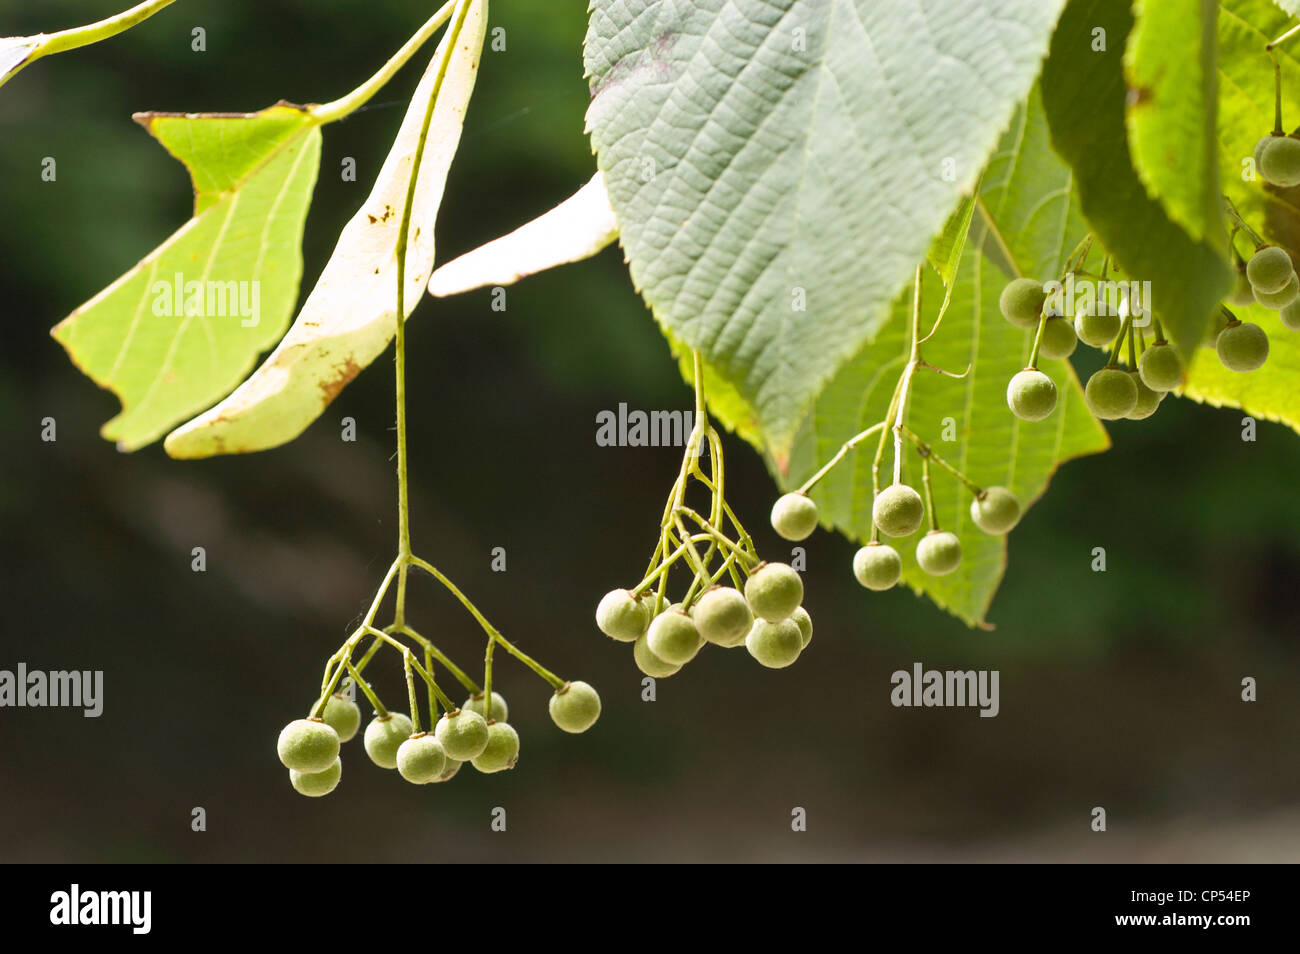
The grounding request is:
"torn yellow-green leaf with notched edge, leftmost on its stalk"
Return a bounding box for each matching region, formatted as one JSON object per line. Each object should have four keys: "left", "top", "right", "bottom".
{"left": 52, "top": 103, "right": 321, "bottom": 451}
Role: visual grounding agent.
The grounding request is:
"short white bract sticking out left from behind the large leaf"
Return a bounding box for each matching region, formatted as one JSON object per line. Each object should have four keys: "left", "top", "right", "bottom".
{"left": 429, "top": 173, "right": 619, "bottom": 298}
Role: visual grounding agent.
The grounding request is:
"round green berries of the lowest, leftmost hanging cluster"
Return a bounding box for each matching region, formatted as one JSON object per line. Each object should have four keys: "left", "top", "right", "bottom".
{"left": 276, "top": 682, "right": 601, "bottom": 798}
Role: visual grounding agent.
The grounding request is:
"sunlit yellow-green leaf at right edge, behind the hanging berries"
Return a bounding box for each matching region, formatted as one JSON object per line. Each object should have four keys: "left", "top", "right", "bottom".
{"left": 1183, "top": 0, "right": 1300, "bottom": 432}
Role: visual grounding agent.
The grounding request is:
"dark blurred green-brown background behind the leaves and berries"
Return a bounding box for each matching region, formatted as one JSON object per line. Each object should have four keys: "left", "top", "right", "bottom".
{"left": 0, "top": 0, "right": 1300, "bottom": 862}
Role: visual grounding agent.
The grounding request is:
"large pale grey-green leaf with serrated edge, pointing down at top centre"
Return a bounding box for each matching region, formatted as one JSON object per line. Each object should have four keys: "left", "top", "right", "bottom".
{"left": 585, "top": 0, "right": 1061, "bottom": 464}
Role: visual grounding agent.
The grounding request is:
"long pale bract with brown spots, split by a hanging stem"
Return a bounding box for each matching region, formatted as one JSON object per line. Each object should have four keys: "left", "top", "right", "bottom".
{"left": 164, "top": 0, "right": 486, "bottom": 458}
